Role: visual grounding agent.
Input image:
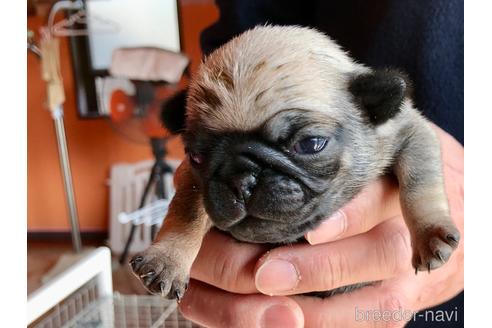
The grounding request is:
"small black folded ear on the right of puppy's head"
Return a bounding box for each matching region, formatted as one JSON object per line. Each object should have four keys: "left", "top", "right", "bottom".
{"left": 349, "top": 69, "right": 410, "bottom": 125}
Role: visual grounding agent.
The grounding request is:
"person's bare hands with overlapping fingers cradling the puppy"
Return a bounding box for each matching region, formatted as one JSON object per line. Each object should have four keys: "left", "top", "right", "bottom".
{"left": 180, "top": 127, "right": 464, "bottom": 327}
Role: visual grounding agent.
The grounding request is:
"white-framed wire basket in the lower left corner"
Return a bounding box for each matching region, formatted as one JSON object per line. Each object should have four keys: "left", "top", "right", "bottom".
{"left": 28, "top": 247, "right": 199, "bottom": 328}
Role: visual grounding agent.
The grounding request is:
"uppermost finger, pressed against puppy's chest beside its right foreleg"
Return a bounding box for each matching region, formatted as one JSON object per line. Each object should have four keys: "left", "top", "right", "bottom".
{"left": 305, "top": 177, "right": 401, "bottom": 245}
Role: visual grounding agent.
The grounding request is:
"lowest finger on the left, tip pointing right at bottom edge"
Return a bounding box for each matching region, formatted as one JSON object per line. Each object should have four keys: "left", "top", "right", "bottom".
{"left": 179, "top": 280, "right": 304, "bottom": 327}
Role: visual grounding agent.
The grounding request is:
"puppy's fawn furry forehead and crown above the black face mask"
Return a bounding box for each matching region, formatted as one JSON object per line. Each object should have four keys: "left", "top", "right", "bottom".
{"left": 187, "top": 26, "right": 364, "bottom": 131}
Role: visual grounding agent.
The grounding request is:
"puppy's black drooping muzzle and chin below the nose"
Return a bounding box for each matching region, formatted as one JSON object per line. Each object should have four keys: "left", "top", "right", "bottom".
{"left": 204, "top": 174, "right": 328, "bottom": 243}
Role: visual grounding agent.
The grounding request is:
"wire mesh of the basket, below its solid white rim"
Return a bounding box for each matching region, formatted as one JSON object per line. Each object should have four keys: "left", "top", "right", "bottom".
{"left": 29, "top": 279, "right": 199, "bottom": 328}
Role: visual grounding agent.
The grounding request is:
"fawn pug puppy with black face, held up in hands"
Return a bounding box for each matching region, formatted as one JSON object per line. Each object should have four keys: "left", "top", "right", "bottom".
{"left": 130, "top": 26, "right": 460, "bottom": 300}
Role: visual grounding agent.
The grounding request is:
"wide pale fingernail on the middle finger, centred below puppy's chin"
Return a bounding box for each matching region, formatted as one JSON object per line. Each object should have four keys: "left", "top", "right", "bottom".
{"left": 255, "top": 259, "right": 300, "bottom": 295}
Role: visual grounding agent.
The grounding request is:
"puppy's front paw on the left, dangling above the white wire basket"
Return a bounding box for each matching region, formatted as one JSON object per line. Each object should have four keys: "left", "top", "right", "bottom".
{"left": 130, "top": 246, "right": 189, "bottom": 302}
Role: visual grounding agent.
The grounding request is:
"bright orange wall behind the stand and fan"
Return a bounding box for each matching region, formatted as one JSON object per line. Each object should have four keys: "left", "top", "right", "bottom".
{"left": 27, "top": 1, "right": 218, "bottom": 231}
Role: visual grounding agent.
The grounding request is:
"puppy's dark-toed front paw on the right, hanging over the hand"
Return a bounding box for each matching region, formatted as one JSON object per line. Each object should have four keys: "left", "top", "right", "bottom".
{"left": 412, "top": 219, "right": 460, "bottom": 274}
